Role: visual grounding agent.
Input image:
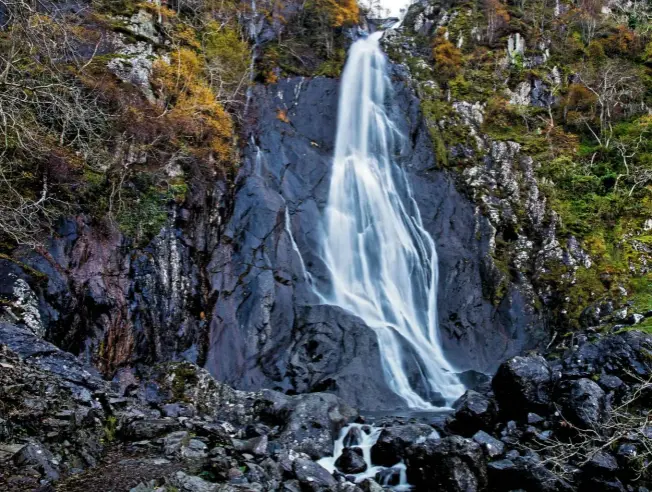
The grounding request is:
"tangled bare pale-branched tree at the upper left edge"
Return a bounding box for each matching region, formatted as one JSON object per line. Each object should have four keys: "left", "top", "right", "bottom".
{"left": 0, "top": 0, "right": 108, "bottom": 246}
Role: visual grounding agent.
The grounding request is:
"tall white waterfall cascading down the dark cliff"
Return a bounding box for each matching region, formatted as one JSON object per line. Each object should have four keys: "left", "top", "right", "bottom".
{"left": 318, "top": 32, "right": 464, "bottom": 410}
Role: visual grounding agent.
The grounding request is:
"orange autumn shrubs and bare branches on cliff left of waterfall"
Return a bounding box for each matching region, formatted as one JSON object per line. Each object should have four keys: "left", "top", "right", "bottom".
{"left": 0, "top": 0, "right": 250, "bottom": 251}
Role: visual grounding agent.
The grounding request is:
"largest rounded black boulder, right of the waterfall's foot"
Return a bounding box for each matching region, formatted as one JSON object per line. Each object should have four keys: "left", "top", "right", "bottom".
{"left": 492, "top": 355, "right": 552, "bottom": 416}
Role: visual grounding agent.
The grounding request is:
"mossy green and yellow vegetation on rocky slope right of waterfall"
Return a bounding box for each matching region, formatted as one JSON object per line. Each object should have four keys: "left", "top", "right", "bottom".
{"left": 388, "top": 0, "right": 652, "bottom": 327}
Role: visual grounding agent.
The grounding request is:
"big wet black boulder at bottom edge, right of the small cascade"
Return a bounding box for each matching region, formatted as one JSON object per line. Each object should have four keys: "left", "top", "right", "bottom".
{"left": 405, "top": 436, "right": 487, "bottom": 492}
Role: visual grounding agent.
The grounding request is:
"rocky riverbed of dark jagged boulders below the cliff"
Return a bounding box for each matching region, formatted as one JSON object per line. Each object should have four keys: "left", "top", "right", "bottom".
{"left": 0, "top": 323, "right": 652, "bottom": 492}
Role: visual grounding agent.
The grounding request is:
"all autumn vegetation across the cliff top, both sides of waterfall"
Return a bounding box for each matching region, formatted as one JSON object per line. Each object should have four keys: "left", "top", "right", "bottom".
{"left": 0, "top": 0, "right": 652, "bottom": 334}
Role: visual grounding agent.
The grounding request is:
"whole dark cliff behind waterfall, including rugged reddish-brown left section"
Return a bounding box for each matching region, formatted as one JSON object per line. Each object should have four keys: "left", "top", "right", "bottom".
{"left": 2, "top": 57, "right": 544, "bottom": 410}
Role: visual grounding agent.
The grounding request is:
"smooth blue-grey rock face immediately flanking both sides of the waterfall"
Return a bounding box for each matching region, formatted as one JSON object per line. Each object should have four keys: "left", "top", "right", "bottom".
{"left": 202, "top": 70, "right": 543, "bottom": 409}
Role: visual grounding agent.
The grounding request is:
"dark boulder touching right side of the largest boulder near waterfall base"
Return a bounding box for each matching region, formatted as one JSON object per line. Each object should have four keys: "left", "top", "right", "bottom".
{"left": 560, "top": 379, "right": 606, "bottom": 429}
